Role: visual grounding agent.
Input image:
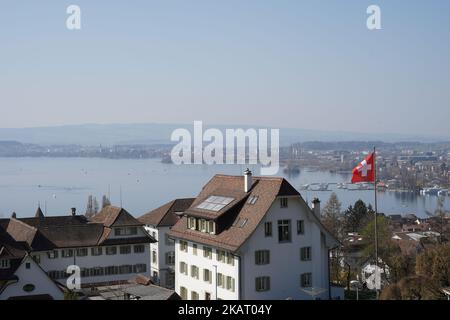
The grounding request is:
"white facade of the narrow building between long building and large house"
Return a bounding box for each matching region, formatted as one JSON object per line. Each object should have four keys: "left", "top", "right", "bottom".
{"left": 145, "top": 226, "right": 175, "bottom": 289}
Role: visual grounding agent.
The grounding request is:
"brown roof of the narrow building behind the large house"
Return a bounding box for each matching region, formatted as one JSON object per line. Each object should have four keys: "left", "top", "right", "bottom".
{"left": 138, "top": 198, "right": 195, "bottom": 227}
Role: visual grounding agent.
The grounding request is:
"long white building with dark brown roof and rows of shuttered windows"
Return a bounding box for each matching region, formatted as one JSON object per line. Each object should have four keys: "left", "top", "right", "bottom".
{"left": 0, "top": 206, "right": 155, "bottom": 292}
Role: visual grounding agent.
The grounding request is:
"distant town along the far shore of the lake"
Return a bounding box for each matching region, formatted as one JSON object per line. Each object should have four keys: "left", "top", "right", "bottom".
{"left": 0, "top": 141, "right": 450, "bottom": 196}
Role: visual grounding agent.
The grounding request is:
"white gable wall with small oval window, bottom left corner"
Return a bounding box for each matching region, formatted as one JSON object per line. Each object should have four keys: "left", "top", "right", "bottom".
{"left": 0, "top": 258, "right": 64, "bottom": 300}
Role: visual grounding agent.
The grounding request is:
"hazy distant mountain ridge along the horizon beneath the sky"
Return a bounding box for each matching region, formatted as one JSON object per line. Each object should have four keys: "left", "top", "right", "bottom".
{"left": 0, "top": 123, "right": 450, "bottom": 145}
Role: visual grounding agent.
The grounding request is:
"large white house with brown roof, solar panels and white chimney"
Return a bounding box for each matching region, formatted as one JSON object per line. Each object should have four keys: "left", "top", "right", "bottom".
{"left": 170, "top": 170, "right": 338, "bottom": 300}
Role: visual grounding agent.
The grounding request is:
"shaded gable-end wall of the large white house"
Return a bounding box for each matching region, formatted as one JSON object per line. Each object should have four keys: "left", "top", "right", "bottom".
{"left": 241, "top": 198, "right": 329, "bottom": 300}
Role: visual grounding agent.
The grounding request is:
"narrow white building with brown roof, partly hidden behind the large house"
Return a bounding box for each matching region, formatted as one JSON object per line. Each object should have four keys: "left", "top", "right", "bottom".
{"left": 138, "top": 198, "right": 194, "bottom": 289}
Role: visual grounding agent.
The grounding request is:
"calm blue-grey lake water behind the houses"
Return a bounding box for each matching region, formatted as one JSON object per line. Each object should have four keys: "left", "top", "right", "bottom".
{"left": 0, "top": 158, "right": 450, "bottom": 217}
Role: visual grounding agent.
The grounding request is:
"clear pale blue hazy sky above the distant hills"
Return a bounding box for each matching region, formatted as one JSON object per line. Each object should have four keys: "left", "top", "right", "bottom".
{"left": 0, "top": 0, "right": 450, "bottom": 136}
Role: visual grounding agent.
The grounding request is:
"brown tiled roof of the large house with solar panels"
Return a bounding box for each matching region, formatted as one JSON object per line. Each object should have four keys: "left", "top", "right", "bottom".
{"left": 170, "top": 175, "right": 300, "bottom": 251}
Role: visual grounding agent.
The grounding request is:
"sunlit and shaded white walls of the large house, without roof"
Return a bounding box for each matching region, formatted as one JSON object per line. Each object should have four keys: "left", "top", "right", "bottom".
{"left": 175, "top": 196, "right": 330, "bottom": 300}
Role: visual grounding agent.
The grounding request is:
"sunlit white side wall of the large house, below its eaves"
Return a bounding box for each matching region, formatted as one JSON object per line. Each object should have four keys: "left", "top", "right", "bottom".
{"left": 175, "top": 239, "right": 239, "bottom": 300}
